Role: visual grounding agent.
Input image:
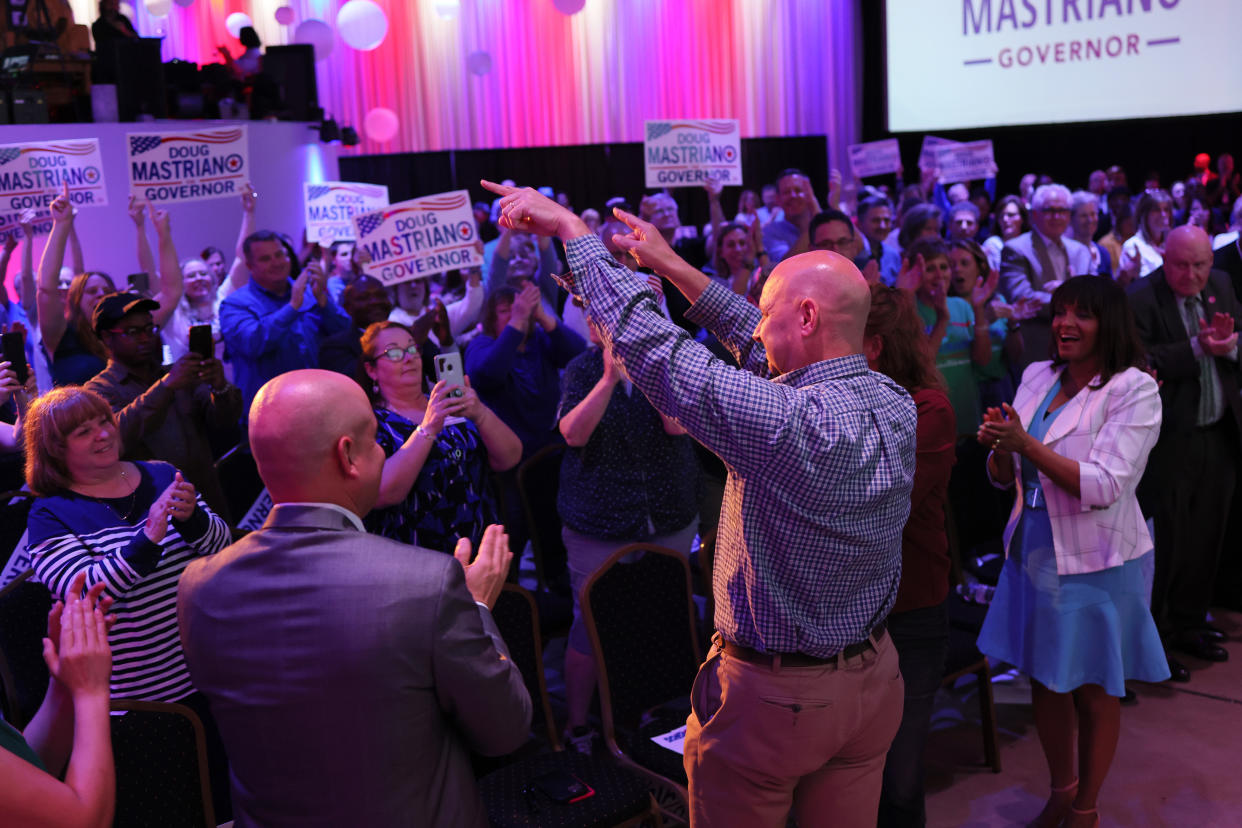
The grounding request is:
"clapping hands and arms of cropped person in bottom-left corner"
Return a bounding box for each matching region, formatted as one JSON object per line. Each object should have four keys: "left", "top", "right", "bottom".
{"left": 0, "top": 572, "right": 117, "bottom": 828}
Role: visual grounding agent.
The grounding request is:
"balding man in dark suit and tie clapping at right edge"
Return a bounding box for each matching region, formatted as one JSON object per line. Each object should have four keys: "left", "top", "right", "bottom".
{"left": 1130, "top": 226, "right": 1242, "bottom": 680}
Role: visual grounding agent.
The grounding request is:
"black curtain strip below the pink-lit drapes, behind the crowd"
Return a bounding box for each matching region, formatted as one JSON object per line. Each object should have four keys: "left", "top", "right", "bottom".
{"left": 340, "top": 135, "right": 828, "bottom": 227}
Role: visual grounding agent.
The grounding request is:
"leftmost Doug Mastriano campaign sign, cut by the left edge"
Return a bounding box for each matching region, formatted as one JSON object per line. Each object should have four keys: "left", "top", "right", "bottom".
{"left": 0, "top": 138, "right": 108, "bottom": 238}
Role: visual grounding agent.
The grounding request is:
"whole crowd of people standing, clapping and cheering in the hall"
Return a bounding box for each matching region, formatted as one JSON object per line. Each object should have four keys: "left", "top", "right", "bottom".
{"left": 0, "top": 145, "right": 1242, "bottom": 826}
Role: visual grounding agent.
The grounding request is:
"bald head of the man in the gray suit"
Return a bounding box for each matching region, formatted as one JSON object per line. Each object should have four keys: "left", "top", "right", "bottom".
{"left": 250, "top": 370, "right": 384, "bottom": 516}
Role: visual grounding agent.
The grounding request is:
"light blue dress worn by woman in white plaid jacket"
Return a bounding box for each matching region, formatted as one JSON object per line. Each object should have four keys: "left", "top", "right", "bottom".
{"left": 979, "top": 380, "right": 1169, "bottom": 696}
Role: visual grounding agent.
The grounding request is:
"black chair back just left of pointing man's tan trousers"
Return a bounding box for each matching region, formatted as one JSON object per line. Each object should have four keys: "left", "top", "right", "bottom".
{"left": 579, "top": 544, "right": 702, "bottom": 739}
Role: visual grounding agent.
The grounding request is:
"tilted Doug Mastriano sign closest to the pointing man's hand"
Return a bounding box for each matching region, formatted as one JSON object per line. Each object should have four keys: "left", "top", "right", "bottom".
{"left": 353, "top": 190, "right": 483, "bottom": 284}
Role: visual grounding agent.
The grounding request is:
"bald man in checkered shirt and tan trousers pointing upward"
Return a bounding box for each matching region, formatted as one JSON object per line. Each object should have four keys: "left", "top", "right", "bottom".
{"left": 483, "top": 181, "right": 915, "bottom": 828}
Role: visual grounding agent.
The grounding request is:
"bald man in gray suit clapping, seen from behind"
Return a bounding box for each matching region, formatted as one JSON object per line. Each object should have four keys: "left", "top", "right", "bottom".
{"left": 178, "top": 370, "right": 532, "bottom": 828}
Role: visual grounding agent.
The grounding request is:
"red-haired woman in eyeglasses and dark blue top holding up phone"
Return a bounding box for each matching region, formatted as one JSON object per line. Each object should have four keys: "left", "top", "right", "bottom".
{"left": 361, "top": 322, "right": 522, "bottom": 555}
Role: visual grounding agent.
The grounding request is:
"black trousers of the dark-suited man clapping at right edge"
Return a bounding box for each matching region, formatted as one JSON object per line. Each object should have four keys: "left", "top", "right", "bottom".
{"left": 1151, "top": 422, "right": 1240, "bottom": 638}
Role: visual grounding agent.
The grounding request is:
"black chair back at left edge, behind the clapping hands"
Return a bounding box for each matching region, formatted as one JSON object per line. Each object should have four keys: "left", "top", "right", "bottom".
{"left": 0, "top": 570, "right": 52, "bottom": 730}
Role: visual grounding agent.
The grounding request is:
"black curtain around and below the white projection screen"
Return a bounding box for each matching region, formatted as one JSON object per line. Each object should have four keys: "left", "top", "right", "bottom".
{"left": 862, "top": 1, "right": 1242, "bottom": 194}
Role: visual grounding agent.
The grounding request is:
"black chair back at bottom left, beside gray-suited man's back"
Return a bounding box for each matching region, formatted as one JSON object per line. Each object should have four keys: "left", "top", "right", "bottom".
{"left": 111, "top": 699, "right": 216, "bottom": 828}
